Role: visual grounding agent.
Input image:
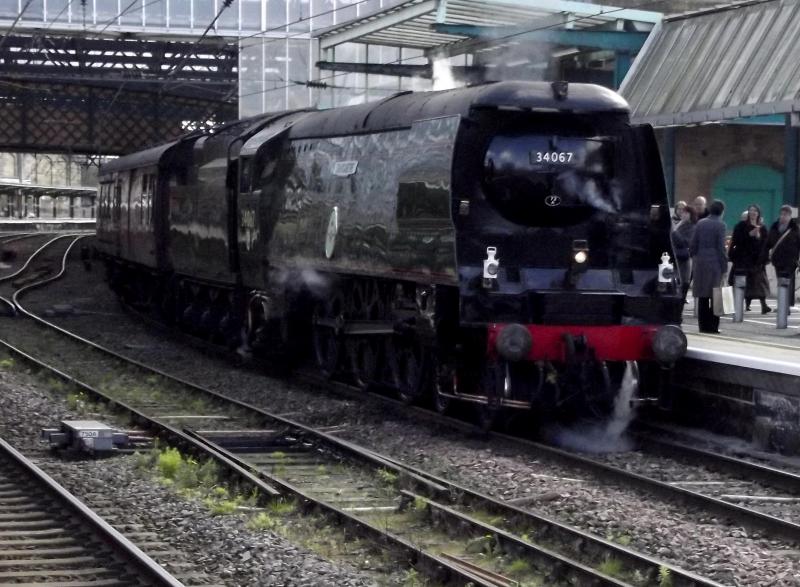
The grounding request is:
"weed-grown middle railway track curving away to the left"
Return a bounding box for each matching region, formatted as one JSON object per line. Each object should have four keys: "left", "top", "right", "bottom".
{"left": 2, "top": 224, "right": 716, "bottom": 586}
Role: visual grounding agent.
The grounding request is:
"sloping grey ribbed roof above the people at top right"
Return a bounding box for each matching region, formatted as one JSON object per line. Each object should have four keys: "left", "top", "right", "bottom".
{"left": 620, "top": 0, "right": 800, "bottom": 126}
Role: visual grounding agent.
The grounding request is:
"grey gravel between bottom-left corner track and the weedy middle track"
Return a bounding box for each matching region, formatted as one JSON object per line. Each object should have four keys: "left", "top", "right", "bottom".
{"left": 0, "top": 369, "right": 373, "bottom": 587}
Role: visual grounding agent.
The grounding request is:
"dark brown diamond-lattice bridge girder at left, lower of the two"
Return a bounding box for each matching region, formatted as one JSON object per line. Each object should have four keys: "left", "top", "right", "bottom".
{"left": 0, "top": 82, "right": 236, "bottom": 155}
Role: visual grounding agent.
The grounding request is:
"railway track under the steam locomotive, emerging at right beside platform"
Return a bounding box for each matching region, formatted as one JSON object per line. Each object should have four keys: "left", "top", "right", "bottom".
{"left": 306, "top": 374, "right": 800, "bottom": 543}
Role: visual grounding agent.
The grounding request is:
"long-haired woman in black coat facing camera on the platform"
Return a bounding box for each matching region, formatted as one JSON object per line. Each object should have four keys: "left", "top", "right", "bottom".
{"left": 728, "top": 204, "right": 772, "bottom": 314}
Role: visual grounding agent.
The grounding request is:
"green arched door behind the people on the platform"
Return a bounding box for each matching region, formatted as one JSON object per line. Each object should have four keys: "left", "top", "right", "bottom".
{"left": 711, "top": 165, "right": 783, "bottom": 232}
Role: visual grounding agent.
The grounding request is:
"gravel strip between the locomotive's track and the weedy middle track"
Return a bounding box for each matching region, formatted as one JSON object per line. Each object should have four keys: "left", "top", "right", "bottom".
{"left": 14, "top": 250, "right": 800, "bottom": 587}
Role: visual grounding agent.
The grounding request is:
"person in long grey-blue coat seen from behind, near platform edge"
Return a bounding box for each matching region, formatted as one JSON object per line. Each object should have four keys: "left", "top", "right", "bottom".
{"left": 689, "top": 200, "right": 728, "bottom": 334}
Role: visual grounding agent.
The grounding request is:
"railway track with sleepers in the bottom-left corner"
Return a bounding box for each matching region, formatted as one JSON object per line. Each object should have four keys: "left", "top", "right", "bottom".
{"left": 0, "top": 432, "right": 181, "bottom": 587}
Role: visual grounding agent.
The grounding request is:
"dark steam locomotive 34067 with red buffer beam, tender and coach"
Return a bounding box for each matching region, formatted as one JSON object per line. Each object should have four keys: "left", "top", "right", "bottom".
{"left": 97, "top": 82, "right": 686, "bottom": 416}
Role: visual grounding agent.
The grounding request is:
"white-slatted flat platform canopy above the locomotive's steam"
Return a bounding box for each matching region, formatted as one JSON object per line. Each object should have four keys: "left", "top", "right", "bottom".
{"left": 314, "top": 0, "right": 661, "bottom": 55}
